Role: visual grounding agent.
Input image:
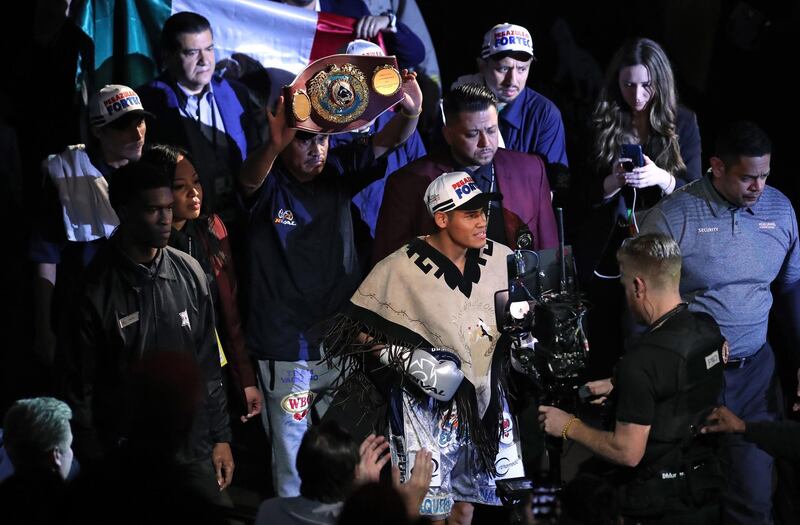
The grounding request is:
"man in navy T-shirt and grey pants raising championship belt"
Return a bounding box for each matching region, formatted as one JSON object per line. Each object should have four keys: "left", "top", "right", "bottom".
{"left": 239, "top": 73, "right": 422, "bottom": 497}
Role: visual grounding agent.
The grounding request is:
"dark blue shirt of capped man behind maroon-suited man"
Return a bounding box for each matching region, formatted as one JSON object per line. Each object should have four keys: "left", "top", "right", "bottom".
{"left": 498, "top": 87, "right": 569, "bottom": 166}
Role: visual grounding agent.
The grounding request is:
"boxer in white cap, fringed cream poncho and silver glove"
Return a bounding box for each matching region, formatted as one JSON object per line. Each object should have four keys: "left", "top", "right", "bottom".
{"left": 326, "top": 171, "right": 524, "bottom": 523}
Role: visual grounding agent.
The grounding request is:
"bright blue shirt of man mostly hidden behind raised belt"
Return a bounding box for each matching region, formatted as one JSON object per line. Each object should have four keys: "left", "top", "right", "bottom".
{"left": 330, "top": 111, "right": 427, "bottom": 239}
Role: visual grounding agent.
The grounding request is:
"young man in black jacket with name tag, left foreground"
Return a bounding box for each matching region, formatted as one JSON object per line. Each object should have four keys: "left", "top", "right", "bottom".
{"left": 75, "top": 163, "right": 234, "bottom": 505}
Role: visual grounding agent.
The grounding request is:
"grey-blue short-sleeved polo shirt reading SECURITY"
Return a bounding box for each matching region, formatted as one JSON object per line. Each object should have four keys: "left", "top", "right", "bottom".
{"left": 639, "top": 175, "right": 800, "bottom": 358}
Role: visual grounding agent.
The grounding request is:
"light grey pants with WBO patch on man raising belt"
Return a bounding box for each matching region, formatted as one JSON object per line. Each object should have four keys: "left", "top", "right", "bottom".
{"left": 258, "top": 359, "right": 338, "bottom": 497}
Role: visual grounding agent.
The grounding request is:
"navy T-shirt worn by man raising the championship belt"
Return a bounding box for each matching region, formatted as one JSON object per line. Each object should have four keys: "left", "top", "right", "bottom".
{"left": 244, "top": 142, "right": 386, "bottom": 361}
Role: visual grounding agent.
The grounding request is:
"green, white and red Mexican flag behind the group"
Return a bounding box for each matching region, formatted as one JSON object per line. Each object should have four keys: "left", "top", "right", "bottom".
{"left": 73, "top": 0, "right": 380, "bottom": 89}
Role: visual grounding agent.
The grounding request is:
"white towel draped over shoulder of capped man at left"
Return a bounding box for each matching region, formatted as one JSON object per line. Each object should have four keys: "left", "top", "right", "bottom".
{"left": 45, "top": 144, "right": 119, "bottom": 242}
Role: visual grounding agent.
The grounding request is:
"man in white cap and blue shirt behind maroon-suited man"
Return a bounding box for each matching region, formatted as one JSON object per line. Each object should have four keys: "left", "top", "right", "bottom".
{"left": 454, "top": 23, "right": 568, "bottom": 166}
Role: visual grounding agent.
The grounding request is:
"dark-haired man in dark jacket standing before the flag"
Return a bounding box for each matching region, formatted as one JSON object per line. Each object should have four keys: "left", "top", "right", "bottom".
{"left": 138, "top": 11, "right": 263, "bottom": 222}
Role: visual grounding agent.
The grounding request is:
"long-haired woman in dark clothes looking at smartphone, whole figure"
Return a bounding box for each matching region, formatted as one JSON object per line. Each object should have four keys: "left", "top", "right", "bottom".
{"left": 576, "top": 38, "right": 701, "bottom": 370}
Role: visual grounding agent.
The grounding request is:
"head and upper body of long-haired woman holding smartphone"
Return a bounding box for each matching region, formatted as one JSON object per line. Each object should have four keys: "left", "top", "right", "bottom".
{"left": 592, "top": 38, "right": 701, "bottom": 210}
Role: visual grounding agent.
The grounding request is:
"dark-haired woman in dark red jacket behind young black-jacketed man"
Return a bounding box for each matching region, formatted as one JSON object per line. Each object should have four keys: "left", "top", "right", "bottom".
{"left": 141, "top": 144, "right": 262, "bottom": 422}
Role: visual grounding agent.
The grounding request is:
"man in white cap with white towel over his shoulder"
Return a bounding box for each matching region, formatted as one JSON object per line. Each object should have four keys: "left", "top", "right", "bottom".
{"left": 28, "top": 85, "right": 152, "bottom": 372}
